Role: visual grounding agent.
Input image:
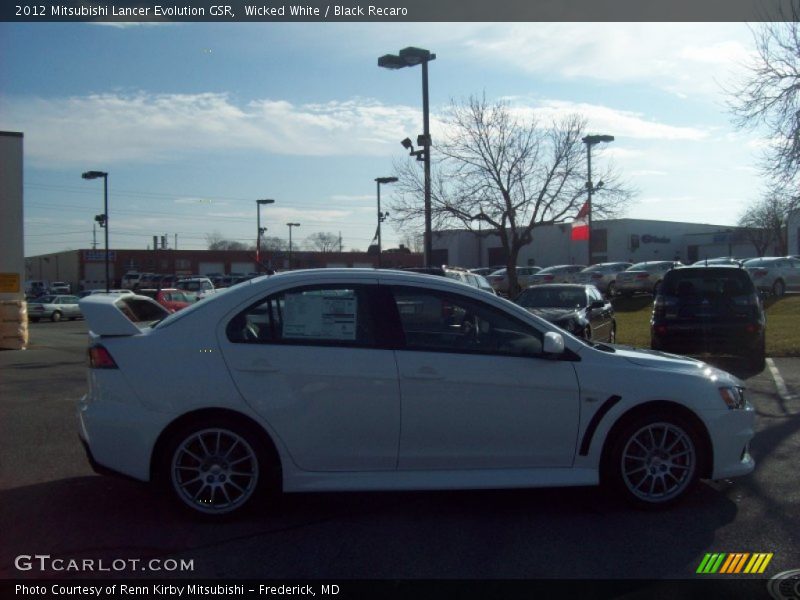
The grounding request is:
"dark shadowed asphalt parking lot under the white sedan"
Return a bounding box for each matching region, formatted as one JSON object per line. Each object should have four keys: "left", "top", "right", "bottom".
{"left": 0, "top": 321, "right": 800, "bottom": 579}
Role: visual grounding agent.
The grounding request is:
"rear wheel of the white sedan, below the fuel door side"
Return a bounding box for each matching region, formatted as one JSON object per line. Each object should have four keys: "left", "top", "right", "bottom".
{"left": 157, "top": 416, "right": 279, "bottom": 519}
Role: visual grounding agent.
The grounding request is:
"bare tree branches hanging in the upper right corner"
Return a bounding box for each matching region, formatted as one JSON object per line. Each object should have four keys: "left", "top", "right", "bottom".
{"left": 729, "top": 7, "right": 800, "bottom": 185}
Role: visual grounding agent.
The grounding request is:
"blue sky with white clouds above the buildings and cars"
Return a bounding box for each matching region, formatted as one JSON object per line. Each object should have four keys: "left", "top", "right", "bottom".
{"left": 0, "top": 22, "right": 764, "bottom": 256}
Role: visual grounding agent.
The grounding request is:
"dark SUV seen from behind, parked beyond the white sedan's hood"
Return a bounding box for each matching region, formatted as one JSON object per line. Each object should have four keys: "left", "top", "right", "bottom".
{"left": 650, "top": 265, "right": 766, "bottom": 370}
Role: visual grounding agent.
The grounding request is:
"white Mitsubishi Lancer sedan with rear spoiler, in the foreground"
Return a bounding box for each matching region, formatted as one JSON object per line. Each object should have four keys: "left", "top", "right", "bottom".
{"left": 78, "top": 269, "right": 754, "bottom": 516}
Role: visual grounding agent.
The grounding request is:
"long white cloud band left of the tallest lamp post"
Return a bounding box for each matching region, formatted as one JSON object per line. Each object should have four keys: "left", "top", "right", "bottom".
{"left": 0, "top": 92, "right": 420, "bottom": 167}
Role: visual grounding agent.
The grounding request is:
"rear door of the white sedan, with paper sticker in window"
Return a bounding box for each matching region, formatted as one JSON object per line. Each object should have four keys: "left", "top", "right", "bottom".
{"left": 218, "top": 284, "right": 400, "bottom": 471}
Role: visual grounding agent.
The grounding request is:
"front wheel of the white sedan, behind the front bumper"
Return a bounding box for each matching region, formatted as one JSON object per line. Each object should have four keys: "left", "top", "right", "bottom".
{"left": 602, "top": 410, "right": 704, "bottom": 509}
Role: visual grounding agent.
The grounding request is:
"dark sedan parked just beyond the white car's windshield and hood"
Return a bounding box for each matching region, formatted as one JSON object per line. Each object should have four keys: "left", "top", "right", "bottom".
{"left": 514, "top": 283, "right": 617, "bottom": 344}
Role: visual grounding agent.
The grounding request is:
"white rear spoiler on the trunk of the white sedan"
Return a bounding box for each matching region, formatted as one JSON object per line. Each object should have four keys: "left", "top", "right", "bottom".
{"left": 78, "top": 294, "right": 170, "bottom": 336}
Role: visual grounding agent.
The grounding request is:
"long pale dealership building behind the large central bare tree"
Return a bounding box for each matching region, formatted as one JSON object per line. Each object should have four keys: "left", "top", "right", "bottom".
{"left": 432, "top": 219, "right": 791, "bottom": 267}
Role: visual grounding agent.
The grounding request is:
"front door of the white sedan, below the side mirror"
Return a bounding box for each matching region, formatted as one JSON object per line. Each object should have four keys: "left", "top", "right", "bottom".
{"left": 392, "top": 286, "right": 579, "bottom": 470}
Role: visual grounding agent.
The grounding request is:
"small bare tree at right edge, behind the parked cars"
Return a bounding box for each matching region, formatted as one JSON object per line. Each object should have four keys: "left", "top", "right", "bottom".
{"left": 739, "top": 185, "right": 800, "bottom": 256}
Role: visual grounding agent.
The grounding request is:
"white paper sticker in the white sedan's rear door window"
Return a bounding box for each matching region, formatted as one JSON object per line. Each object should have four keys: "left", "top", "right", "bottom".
{"left": 283, "top": 290, "right": 358, "bottom": 341}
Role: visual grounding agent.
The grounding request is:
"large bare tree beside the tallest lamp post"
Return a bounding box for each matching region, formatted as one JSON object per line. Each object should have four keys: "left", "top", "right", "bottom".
{"left": 392, "top": 96, "right": 633, "bottom": 291}
